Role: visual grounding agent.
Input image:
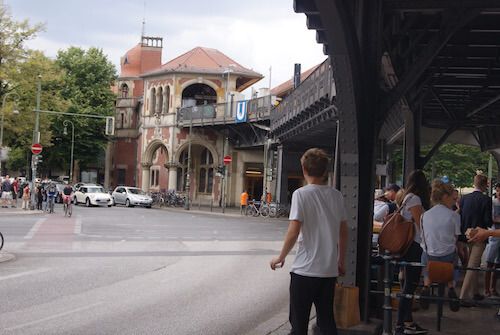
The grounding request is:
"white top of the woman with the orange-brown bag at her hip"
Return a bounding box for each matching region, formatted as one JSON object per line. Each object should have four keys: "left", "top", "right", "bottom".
{"left": 420, "top": 204, "right": 461, "bottom": 257}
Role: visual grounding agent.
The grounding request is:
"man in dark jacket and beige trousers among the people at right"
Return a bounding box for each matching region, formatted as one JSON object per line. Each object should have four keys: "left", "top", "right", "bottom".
{"left": 460, "top": 174, "right": 493, "bottom": 307}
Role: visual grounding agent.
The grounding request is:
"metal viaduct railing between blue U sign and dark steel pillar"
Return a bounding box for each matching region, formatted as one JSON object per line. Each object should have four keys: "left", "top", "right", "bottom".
{"left": 271, "top": 60, "right": 333, "bottom": 132}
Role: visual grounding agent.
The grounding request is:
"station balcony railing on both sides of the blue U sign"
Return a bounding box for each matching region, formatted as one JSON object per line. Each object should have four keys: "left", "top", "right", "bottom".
{"left": 177, "top": 96, "right": 271, "bottom": 127}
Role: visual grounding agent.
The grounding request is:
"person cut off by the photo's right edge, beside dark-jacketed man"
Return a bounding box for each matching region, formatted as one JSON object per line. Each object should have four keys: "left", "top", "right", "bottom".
{"left": 484, "top": 183, "right": 500, "bottom": 297}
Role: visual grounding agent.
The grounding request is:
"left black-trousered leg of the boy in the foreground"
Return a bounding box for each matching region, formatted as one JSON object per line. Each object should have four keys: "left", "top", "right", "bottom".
{"left": 289, "top": 273, "right": 312, "bottom": 335}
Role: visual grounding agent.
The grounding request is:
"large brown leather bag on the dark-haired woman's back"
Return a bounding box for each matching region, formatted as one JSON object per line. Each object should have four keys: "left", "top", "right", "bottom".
{"left": 378, "top": 195, "right": 415, "bottom": 257}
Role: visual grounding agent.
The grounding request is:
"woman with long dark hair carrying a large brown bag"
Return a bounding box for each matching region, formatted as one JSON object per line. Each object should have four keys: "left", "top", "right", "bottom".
{"left": 395, "top": 170, "right": 430, "bottom": 335}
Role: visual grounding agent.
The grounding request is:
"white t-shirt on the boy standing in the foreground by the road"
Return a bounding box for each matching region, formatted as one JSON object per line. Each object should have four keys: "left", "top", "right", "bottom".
{"left": 289, "top": 184, "right": 347, "bottom": 278}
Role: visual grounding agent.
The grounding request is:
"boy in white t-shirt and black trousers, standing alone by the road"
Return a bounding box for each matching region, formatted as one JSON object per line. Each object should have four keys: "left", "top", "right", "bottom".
{"left": 270, "top": 148, "right": 348, "bottom": 335}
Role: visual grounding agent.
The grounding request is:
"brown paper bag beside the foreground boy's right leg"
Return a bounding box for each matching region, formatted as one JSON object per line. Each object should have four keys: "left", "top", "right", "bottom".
{"left": 333, "top": 284, "right": 361, "bottom": 328}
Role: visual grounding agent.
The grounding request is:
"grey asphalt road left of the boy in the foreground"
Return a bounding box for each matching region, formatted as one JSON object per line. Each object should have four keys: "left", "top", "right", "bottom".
{"left": 0, "top": 206, "right": 293, "bottom": 335}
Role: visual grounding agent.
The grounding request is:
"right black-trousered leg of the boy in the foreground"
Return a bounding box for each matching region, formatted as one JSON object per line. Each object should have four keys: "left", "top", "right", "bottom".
{"left": 314, "top": 278, "right": 337, "bottom": 335}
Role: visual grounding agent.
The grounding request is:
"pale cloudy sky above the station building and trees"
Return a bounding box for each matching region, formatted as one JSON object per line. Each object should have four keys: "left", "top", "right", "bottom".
{"left": 7, "top": 0, "right": 326, "bottom": 94}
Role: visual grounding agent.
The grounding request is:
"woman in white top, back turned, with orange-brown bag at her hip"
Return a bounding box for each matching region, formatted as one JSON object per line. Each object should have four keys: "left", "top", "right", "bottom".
{"left": 420, "top": 180, "right": 461, "bottom": 312}
